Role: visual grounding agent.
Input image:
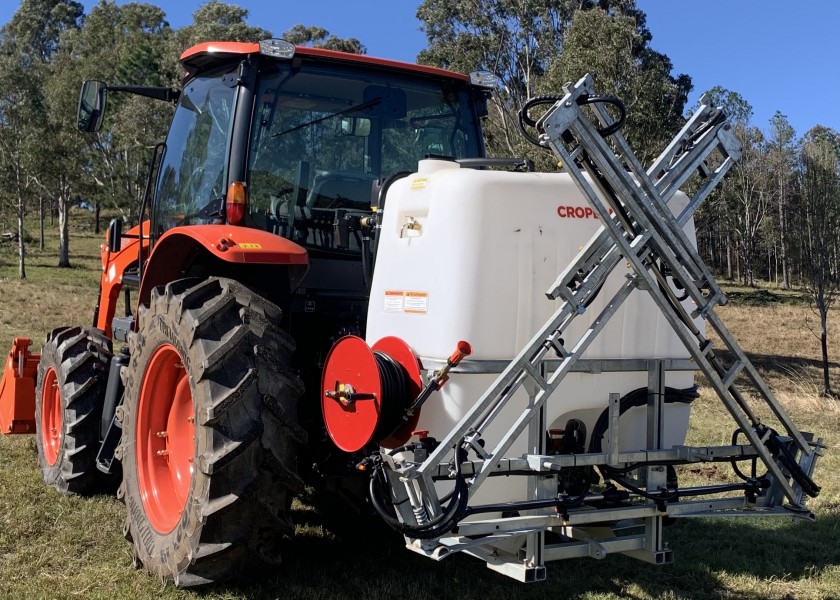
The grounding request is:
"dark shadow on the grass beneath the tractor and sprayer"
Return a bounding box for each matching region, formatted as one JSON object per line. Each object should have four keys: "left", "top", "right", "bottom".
{"left": 208, "top": 512, "right": 840, "bottom": 600}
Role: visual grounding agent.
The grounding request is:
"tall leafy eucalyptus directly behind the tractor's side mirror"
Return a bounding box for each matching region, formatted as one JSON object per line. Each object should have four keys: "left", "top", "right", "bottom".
{"left": 51, "top": 1, "right": 177, "bottom": 231}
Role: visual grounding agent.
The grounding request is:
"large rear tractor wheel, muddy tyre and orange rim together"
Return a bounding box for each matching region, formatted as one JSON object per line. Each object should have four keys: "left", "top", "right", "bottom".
{"left": 120, "top": 278, "right": 305, "bottom": 587}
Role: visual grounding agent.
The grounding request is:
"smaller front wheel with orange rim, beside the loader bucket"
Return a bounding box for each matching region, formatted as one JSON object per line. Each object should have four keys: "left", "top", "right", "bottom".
{"left": 35, "top": 327, "right": 116, "bottom": 494}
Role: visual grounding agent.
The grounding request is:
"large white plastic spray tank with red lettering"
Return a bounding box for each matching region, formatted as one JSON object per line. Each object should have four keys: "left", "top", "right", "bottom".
{"left": 367, "top": 160, "right": 703, "bottom": 502}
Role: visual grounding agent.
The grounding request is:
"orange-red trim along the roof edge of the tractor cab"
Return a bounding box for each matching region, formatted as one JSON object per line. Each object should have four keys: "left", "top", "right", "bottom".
{"left": 181, "top": 42, "right": 469, "bottom": 81}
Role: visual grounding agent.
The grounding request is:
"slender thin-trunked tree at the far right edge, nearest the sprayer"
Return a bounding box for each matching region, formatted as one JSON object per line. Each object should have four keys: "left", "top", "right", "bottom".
{"left": 798, "top": 126, "right": 840, "bottom": 397}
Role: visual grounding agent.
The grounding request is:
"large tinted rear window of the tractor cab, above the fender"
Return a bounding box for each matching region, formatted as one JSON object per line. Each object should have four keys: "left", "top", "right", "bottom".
{"left": 247, "top": 64, "right": 480, "bottom": 252}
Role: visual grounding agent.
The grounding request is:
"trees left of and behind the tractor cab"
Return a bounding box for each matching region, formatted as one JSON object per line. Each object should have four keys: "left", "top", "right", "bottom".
{"left": 0, "top": 0, "right": 366, "bottom": 279}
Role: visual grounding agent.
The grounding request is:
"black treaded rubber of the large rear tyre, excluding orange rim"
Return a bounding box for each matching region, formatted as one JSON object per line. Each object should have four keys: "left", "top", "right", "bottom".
{"left": 120, "top": 278, "right": 305, "bottom": 587}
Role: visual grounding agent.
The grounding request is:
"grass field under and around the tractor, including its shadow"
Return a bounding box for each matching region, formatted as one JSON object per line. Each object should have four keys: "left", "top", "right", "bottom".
{"left": 0, "top": 212, "right": 840, "bottom": 600}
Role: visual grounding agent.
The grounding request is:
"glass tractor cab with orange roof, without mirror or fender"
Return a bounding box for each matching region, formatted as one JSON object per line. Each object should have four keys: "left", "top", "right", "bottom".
{"left": 162, "top": 40, "right": 486, "bottom": 252}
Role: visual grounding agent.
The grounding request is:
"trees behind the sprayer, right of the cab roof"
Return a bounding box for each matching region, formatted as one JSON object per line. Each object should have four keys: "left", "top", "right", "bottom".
{"left": 417, "top": 0, "right": 840, "bottom": 395}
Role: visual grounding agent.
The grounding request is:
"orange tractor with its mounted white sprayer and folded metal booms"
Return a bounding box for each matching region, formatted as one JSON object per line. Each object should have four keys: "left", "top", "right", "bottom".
{"left": 0, "top": 40, "right": 822, "bottom": 587}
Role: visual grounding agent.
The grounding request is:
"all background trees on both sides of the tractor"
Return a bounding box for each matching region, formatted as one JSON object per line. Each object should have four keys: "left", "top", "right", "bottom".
{"left": 0, "top": 0, "right": 840, "bottom": 390}
